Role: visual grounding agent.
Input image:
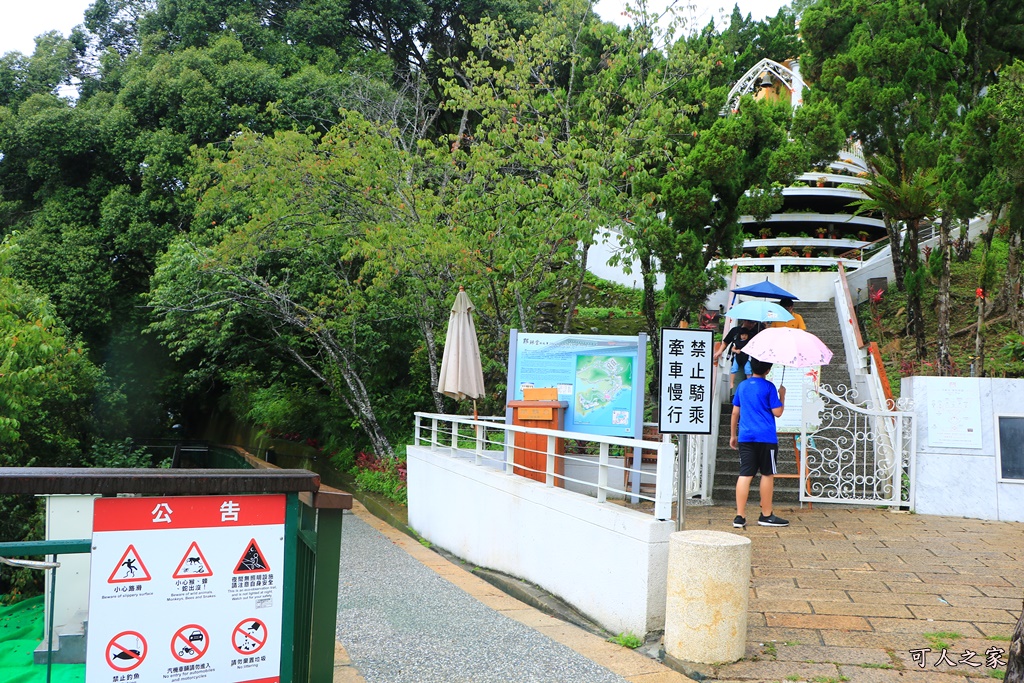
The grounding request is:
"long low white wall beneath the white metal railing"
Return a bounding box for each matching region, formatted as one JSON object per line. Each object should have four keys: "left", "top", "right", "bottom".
{"left": 407, "top": 446, "right": 675, "bottom": 636}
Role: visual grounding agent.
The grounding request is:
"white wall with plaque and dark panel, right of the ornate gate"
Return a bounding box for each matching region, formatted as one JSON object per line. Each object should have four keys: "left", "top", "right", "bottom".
{"left": 900, "top": 377, "right": 1024, "bottom": 522}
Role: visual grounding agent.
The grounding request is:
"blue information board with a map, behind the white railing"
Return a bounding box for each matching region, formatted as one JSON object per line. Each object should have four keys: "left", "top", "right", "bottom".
{"left": 508, "top": 330, "right": 647, "bottom": 438}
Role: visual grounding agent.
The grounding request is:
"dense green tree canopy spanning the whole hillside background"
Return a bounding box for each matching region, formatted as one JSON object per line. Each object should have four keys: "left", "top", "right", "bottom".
{"left": 0, "top": 0, "right": 1024, "bottom": 458}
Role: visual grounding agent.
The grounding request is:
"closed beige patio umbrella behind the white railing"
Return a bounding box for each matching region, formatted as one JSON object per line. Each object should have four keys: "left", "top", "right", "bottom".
{"left": 437, "top": 287, "right": 484, "bottom": 420}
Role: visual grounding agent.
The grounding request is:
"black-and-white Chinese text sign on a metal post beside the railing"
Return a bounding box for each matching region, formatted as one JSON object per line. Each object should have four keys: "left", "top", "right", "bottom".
{"left": 657, "top": 328, "right": 714, "bottom": 531}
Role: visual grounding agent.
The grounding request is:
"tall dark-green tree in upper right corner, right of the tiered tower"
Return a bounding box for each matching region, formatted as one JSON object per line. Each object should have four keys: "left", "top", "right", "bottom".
{"left": 801, "top": 0, "right": 1024, "bottom": 374}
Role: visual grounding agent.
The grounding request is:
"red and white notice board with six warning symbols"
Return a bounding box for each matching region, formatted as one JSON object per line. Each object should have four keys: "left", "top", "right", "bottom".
{"left": 85, "top": 495, "right": 285, "bottom": 683}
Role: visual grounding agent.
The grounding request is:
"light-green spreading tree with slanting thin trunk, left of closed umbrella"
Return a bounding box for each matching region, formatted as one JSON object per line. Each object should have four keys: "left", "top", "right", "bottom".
{"left": 151, "top": 114, "right": 440, "bottom": 457}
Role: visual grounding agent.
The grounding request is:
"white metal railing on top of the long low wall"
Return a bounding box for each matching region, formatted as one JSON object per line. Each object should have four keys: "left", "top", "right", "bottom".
{"left": 412, "top": 413, "right": 676, "bottom": 519}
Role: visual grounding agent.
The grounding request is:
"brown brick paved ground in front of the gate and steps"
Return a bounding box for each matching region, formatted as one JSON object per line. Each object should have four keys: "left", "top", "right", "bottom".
{"left": 686, "top": 505, "right": 1024, "bottom": 683}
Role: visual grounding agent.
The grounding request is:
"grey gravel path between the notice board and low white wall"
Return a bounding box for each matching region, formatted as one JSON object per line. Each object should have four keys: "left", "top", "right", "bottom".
{"left": 338, "top": 514, "right": 625, "bottom": 683}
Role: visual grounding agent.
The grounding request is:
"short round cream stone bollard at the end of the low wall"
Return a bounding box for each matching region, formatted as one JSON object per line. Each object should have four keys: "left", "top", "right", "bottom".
{"left": 665, "top": 530, "right": 751, "bottom": 664}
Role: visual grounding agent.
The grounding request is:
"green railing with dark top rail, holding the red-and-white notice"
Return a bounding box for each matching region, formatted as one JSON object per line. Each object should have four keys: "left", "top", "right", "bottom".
{"left": 0, "top": 468, "right": 352, "bottom": 683}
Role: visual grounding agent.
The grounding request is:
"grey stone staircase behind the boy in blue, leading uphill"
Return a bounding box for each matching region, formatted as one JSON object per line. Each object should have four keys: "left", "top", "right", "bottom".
{"left": 712, "top": 301, "right": 850, "bottom": 505}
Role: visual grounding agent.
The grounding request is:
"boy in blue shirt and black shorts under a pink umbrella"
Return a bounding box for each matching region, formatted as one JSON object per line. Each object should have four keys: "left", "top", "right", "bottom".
{"left": 729, "top": 358, "right": 790, "bottom": 528}
